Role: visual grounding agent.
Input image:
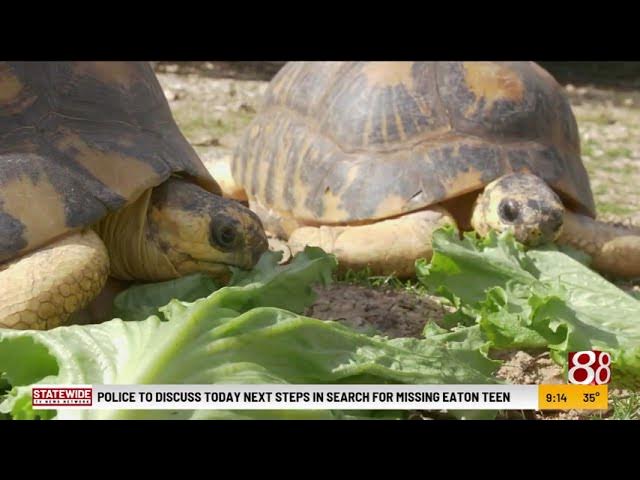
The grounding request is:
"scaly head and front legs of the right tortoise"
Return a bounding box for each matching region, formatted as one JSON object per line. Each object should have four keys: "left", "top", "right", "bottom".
{"left": 286, "top": 173, "right": 640, "bottom": 277}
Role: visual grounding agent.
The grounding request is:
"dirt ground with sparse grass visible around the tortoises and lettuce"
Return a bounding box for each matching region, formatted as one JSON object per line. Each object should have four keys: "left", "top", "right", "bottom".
{"left": 155, "top": 62, "right": 640, "bottom": 418}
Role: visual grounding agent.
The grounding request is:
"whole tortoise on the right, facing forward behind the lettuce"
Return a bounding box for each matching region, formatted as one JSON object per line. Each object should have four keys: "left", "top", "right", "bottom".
{"left": 231, "top": 62, "right": 640, "bottom": 277}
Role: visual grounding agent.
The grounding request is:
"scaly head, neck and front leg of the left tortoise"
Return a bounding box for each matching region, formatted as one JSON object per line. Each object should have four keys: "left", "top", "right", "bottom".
{"left": 0, "top": 178, "right": 267, "bottom": 330}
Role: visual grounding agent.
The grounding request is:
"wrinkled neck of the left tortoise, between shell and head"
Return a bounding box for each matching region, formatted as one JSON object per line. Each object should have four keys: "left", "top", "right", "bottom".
{"left": 95, "top": 189, "right": 179, "bottom": 281}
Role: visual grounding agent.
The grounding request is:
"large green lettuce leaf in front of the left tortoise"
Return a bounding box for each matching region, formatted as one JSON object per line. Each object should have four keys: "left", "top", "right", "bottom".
{"left": 0, "top": 248, "right": 497, "bottom": 419}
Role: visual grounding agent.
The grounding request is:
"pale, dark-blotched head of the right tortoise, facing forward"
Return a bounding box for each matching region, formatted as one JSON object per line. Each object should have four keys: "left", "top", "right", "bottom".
{"left": 471, "top": 173, "right": 564, "bottom": 246}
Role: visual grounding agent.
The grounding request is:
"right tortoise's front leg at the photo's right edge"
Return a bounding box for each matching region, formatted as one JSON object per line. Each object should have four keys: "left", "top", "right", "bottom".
{"left": 558, "top": 212, "right": 640, "bottom": 278}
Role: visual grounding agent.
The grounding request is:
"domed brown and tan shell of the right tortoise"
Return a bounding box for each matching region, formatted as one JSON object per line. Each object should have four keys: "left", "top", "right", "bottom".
{"left": 232, "top": 62, "right": 595, "bottom": 224}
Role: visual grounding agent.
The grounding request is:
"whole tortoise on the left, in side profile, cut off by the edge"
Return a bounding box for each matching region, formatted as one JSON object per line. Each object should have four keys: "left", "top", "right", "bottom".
{"left": 0, "top": 62, "right": 267, "bottom": 329}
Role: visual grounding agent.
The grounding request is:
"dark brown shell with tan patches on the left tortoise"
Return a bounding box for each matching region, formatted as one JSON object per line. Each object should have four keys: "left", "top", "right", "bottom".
{"left": 0, "top": 62, "right": 220, "bottom": 263}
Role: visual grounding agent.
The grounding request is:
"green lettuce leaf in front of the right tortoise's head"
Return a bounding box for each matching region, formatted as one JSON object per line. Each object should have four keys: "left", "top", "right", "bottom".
{"left": 416, "top": 228, "right": 640, "bottom": 384}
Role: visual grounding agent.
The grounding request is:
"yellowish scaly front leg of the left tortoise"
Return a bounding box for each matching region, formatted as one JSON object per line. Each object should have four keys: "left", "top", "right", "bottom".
{"left": 0, "top": 230, "right": 109, "bottom": 330}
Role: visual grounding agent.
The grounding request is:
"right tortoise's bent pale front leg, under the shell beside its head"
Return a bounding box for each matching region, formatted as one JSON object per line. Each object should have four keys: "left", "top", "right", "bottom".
{"left": 289, "top": 207, "right": 456, "bottom": 278}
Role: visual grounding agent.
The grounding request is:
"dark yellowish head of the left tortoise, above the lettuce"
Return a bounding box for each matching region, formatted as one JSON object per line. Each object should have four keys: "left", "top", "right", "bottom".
{"left": 147, "top": 178, "right": 268, "bottom": 277}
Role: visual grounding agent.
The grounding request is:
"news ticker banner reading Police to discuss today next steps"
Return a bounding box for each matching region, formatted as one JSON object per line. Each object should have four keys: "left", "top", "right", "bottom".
{"left": 31, "top": 384, "right": 608, "bottom": 410}
